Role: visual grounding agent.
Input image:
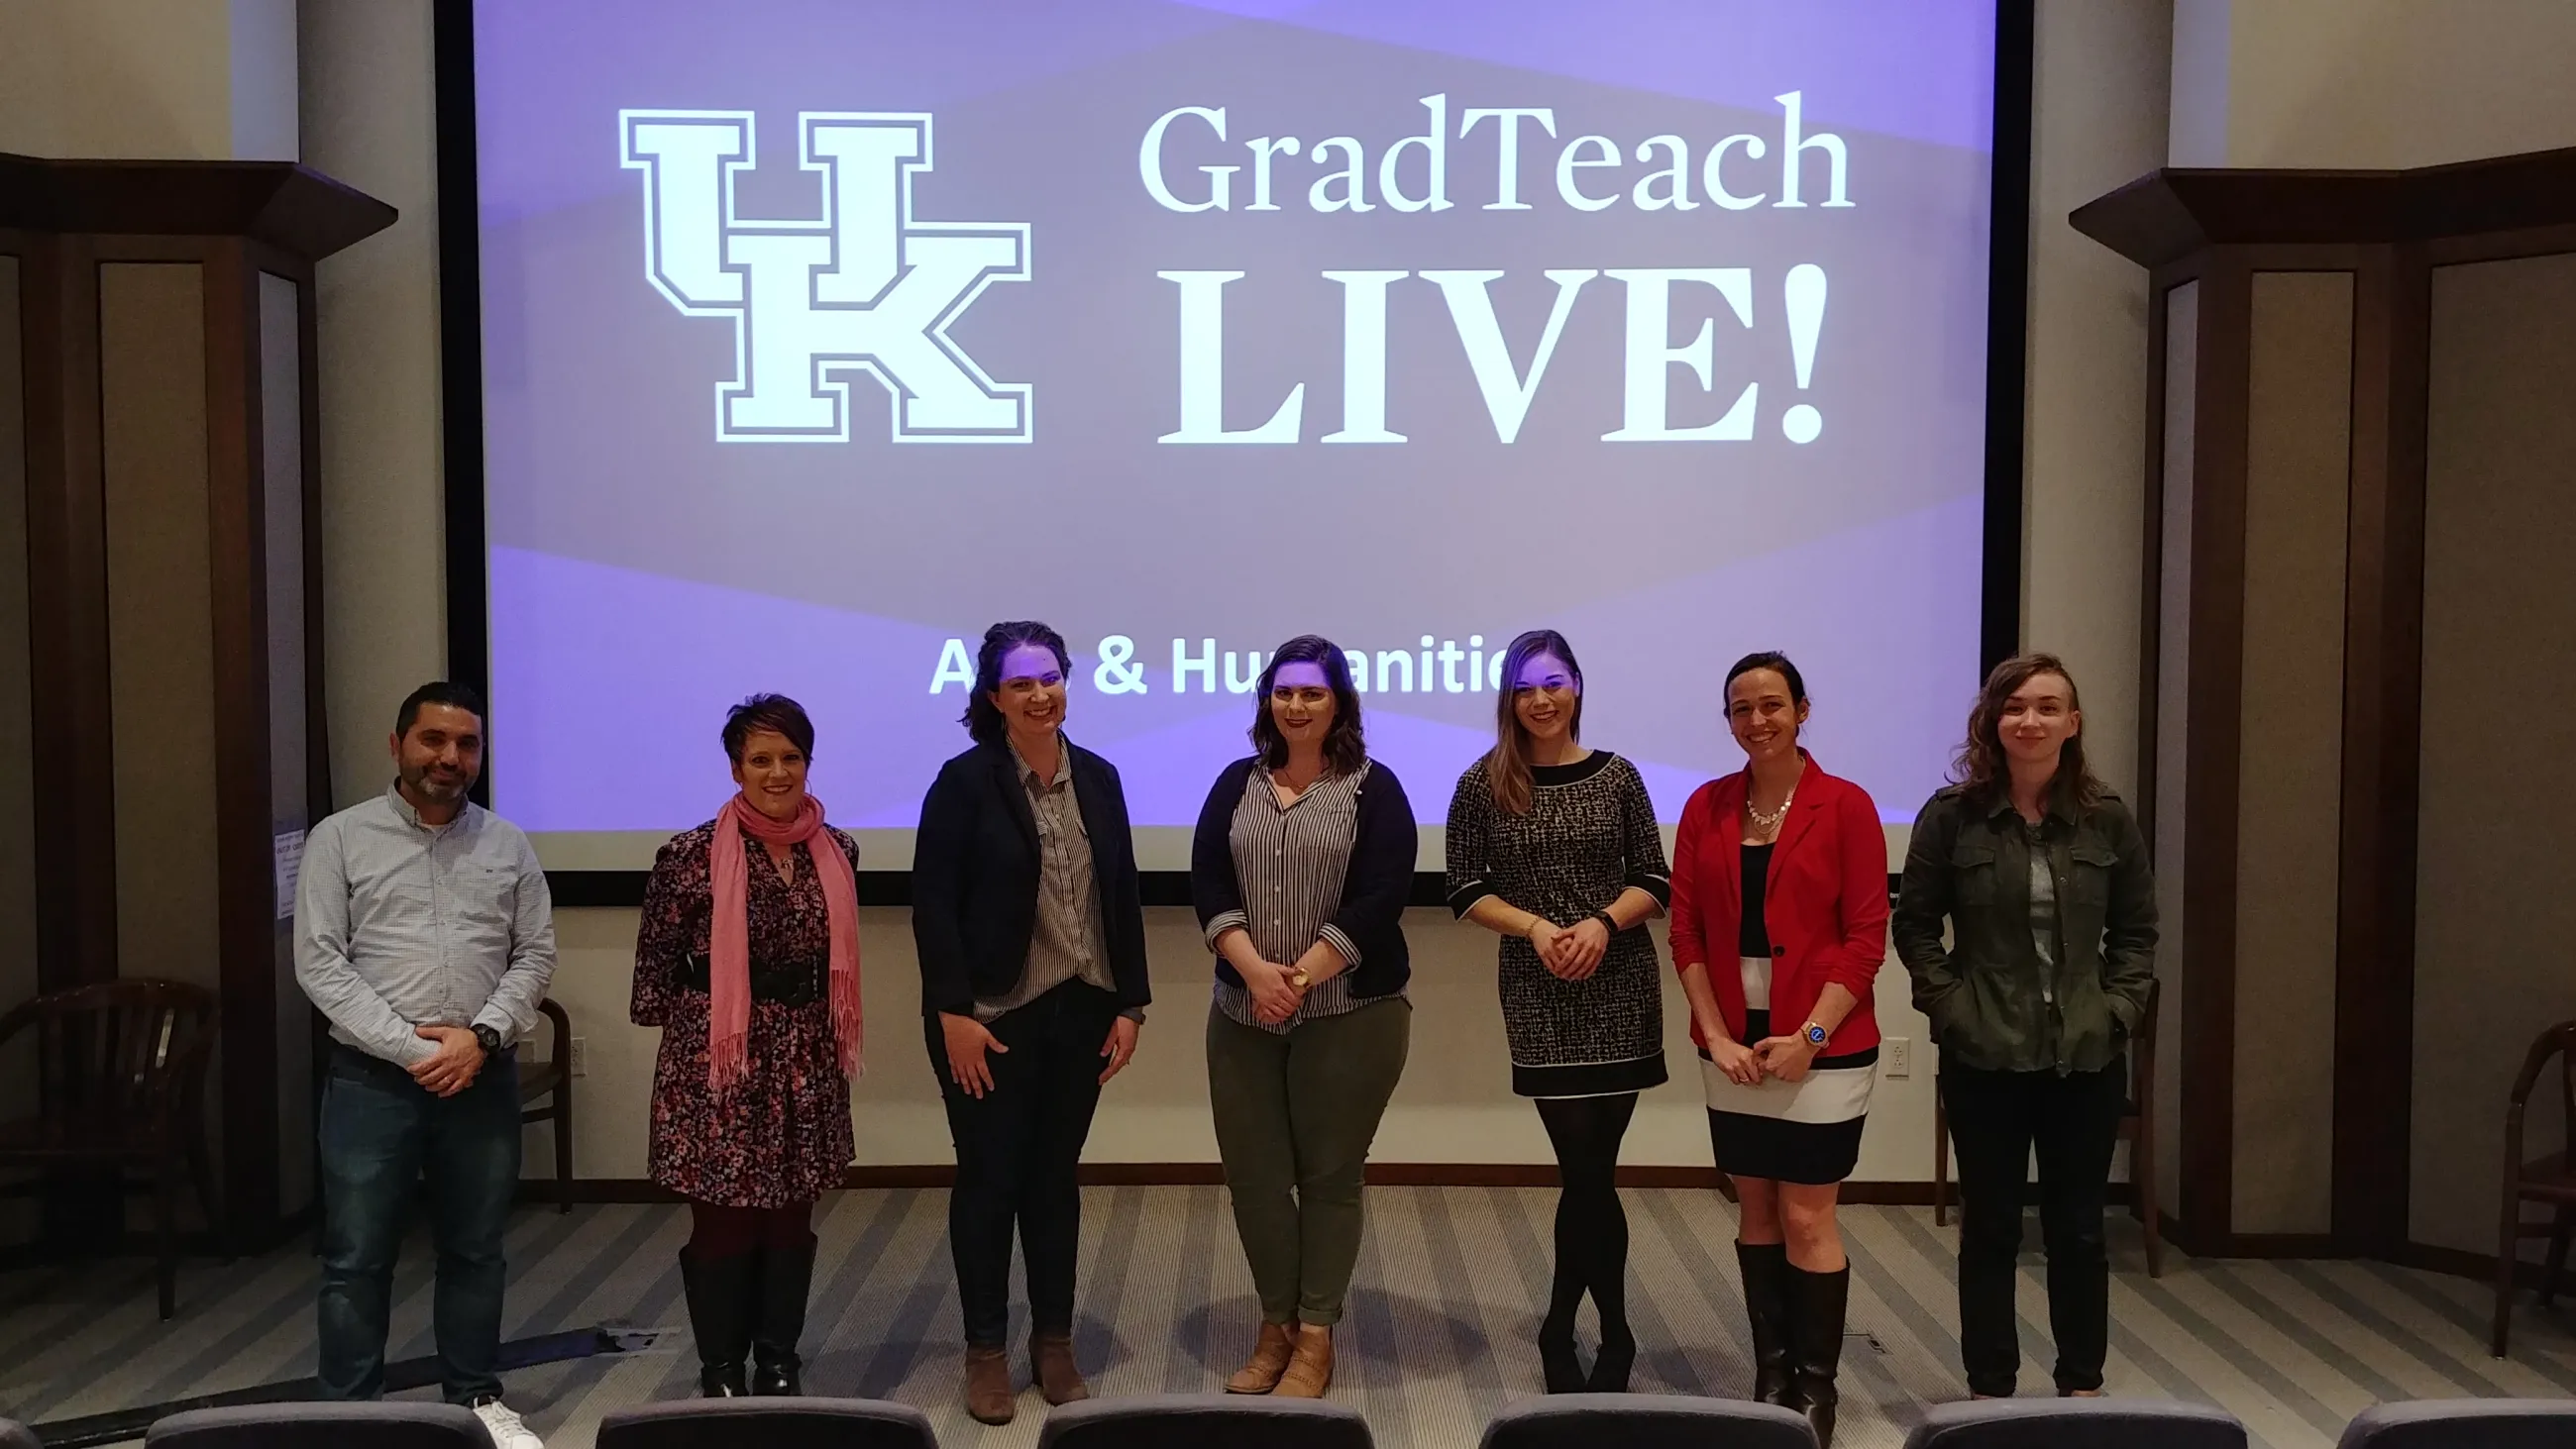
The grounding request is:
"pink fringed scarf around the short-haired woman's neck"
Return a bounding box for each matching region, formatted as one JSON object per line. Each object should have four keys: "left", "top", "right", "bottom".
{"left": 705, "top": 795, "right": 863, "bottom": 1091}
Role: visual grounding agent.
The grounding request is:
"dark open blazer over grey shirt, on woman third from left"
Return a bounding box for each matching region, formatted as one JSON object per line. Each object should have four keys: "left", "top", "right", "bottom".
{"left": 912, "top": 741, "right": 1154, "bottom": 1016}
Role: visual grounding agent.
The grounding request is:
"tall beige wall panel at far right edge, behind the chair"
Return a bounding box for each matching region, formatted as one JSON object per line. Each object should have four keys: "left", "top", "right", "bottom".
{"left": 2412, "top": 255, "right": 2576, "bottom": 1254}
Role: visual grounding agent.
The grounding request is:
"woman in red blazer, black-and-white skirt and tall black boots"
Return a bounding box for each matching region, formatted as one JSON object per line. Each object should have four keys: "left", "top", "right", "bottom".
{"left": 1671, "top": 654, "right": 1888, "bottom": 1449}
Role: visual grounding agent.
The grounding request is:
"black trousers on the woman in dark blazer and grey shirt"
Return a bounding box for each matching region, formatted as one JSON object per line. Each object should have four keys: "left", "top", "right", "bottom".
{"left": 924, "top": 981, "right": 1118, "bottom": 1346}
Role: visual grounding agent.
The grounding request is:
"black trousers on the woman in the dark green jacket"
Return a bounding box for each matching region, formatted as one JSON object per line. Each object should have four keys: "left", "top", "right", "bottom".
{"left": 1940, "top": 1061, "right": 2128, "bottom": 1395}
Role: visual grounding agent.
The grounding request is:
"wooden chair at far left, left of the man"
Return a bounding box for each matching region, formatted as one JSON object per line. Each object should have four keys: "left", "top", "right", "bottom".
{"left": 0, "top": 978, "right": 224, "bottom": 1317}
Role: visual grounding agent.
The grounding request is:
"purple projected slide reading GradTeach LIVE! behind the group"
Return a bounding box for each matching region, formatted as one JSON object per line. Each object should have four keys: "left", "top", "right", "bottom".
{"left": 474, "top": 0, "right": 1993, "bottom": 844}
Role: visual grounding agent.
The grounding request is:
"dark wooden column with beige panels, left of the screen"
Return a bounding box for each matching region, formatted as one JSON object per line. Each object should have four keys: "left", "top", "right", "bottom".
{"left": 0, "top": 155, "right": 394, "bottom": 1248}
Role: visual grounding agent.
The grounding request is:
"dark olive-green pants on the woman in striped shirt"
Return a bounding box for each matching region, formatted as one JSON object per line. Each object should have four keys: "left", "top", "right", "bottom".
{"left": 1208, "top": 996, "right": 1414, "bottom": 1325}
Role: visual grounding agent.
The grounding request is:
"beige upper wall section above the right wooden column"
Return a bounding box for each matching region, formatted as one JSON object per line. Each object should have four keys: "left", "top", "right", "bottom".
{"left": 2172, "top": 0, "right": 2576, "bottom": 167}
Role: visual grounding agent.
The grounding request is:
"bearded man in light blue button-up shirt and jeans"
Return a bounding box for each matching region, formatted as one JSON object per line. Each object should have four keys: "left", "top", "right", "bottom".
{"left": 296, "top": 684, "right": 554, "bottom": 1449}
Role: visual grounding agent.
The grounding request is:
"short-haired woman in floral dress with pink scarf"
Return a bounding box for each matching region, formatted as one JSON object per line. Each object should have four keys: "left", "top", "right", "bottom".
{"left": 631, "top": 695, "right": 860, "bottom": 1397}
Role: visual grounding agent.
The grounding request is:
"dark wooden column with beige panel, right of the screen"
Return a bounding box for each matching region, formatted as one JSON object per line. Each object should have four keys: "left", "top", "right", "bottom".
{"left": 2071, "top": 150, "right": 2576, "bottom": 1256}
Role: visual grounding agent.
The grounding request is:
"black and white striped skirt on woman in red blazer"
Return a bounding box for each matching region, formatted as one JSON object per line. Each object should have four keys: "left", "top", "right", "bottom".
{"left": 1700, "top": 958, "right": 1878, "bottom": 1184}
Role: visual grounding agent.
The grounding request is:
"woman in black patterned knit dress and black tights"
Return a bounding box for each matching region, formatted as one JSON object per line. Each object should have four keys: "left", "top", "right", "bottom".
{"left": 1448, "top": 628, "right": 1671, "bottom": 1393}
